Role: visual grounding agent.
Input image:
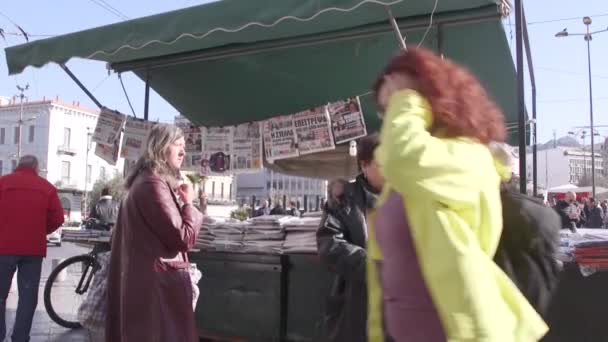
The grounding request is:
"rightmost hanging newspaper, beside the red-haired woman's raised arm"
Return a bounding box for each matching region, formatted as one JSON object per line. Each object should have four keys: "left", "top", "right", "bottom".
{"left": 327, "top": 97, "right": 367, "bottom": 144}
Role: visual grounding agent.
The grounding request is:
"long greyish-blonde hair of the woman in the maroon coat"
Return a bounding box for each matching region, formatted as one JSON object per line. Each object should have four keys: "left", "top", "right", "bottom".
{"left": 125, "top": 123, "right": 184, "bottom": 189}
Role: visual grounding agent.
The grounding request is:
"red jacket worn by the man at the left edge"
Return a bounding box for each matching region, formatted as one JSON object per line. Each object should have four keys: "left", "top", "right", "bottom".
{"left": 0, "top": 167, "right": 63, "bottom": 256}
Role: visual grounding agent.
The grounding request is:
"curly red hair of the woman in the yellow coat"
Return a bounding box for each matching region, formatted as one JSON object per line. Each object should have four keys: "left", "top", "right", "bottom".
{"left": 373, "top": 47, "right": 506, "bottom": 144}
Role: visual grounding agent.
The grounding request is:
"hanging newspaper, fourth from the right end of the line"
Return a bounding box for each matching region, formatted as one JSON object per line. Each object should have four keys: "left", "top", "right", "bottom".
{"left": 231, "top": 122, "right": 262, "bottom": 173}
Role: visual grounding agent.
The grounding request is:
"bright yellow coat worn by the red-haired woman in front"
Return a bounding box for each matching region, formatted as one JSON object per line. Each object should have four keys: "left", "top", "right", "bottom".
{"left": 370, "top": 90, "right": 548, "bottom": 342}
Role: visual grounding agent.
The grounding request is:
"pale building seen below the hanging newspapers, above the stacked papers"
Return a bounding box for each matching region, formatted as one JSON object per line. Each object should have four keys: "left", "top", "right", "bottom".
{"left": 235, "top": 169, "right": 327, "bottom": 211}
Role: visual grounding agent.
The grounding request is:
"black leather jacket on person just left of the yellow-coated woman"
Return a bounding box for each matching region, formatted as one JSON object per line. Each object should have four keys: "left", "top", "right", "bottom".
{"left": 317, "top": 176, "right": 376, "bottom": 342}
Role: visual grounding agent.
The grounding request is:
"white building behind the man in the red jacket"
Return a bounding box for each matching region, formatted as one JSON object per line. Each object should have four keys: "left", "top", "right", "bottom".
{"left": 0, "top": 99, "right": 123, "bottom": 221}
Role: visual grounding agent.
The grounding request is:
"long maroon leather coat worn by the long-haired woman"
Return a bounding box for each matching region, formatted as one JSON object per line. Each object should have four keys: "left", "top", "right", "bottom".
{"left": 106, "top": 171, "right": 203, "bottom": 342}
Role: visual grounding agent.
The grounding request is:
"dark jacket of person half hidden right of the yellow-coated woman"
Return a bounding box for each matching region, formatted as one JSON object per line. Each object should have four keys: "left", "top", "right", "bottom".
{"left": 494, "top": 190, "right": 561, "bottom": 317}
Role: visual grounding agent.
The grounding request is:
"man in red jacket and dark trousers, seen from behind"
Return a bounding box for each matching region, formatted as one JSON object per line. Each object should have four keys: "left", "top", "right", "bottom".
{"left": 0, "top": 156, "right": 63, "bottom": 342}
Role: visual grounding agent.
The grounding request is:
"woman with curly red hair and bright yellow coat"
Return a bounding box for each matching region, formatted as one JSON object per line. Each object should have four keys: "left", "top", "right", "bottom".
{"left": 368, "top": 48, "right": 548, "bottom": 342}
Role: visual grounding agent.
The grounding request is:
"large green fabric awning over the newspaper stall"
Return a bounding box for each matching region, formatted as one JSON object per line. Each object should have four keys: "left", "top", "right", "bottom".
{"left": 6, "top": 0, "right": 517, "bottom": 142}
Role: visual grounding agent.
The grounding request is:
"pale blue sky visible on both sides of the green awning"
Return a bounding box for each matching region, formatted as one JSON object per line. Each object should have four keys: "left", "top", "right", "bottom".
{"left": 0, "top": 0, "right": 608, "bottom": 144}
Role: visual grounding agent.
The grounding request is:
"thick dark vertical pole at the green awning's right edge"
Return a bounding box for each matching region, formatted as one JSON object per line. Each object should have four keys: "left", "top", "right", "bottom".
{"left": 515, "top": 0, "right": 528, "bottom": 194}
